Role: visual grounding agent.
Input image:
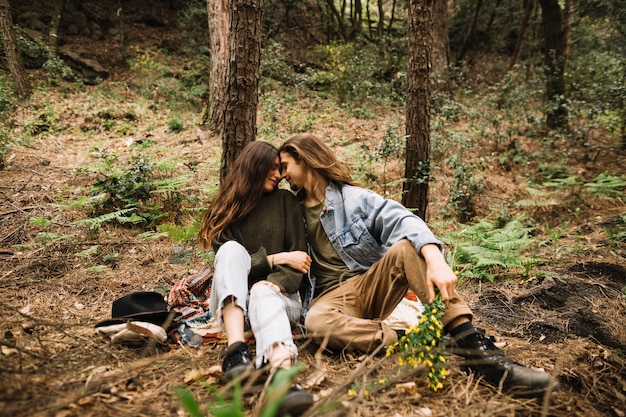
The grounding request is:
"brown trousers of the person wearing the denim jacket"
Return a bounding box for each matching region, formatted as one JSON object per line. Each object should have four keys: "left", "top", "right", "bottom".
{"left": 305, "top": 239, "right": 473, "bottom": 353}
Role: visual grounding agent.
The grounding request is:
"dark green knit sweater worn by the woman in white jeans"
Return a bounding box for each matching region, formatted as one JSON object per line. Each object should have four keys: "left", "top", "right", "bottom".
{"left": 212, "top": 189, "right": 307, "bottom": 295}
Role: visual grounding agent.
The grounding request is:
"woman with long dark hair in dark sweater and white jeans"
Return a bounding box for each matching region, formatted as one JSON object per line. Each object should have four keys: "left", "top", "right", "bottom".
{"left": 198, "top": 141, "right": 313, "bottom": 416}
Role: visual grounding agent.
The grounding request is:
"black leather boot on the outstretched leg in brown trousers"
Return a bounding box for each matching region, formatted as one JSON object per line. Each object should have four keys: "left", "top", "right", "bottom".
{"left": 451, "top": 330, "right": 558, "bottom": 397}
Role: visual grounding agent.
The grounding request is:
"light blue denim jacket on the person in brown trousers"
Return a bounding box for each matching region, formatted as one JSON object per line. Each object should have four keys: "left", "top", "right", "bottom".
{"left": 298, "top": 181, "right": 443, "bottom": 314}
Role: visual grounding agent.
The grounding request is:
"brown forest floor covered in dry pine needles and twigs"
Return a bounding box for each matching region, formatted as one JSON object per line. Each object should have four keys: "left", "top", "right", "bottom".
{"left": 0, "top": 4, "right": 626, "bottom": 417}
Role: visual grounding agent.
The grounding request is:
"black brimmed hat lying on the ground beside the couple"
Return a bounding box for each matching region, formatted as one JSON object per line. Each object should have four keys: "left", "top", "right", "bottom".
{"left": 96, "top": 291, "right": 169, "bottom": 327}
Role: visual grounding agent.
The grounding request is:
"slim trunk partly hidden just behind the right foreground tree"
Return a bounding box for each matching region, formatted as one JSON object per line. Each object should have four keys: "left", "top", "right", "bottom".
{"left": 432, "top": 0, "right": 452, "bottom": 97}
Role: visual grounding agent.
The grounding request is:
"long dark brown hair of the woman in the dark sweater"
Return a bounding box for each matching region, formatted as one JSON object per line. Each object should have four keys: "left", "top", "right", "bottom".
{"left": 198, "top": 141, "right": 278, "bottom": 249}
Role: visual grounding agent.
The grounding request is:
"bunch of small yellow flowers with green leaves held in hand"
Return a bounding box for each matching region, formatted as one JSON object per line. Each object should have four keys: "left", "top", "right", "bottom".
{"left": 387, "top": 294, "right": 448, "bottom": 391}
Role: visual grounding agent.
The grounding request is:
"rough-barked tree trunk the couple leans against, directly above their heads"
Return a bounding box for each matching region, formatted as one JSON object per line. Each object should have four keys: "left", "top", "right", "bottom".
{"left": 220, "top": 0, "right": 263, "bottom": 180}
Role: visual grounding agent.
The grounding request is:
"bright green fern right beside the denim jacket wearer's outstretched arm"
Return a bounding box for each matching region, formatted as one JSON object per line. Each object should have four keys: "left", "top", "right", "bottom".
{"left": 442, "top": 217, "right": 537, "bottom": 281}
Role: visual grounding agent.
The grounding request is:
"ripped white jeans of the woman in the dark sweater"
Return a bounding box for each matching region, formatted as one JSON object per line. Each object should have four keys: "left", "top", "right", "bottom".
{"left": 209, "top": 240, "right": 302, "bottom": 367}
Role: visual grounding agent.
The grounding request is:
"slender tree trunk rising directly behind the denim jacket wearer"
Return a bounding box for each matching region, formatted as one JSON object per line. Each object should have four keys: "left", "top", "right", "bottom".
{"left": 402, "top": 0, "right": 435, "bottom": 220}
